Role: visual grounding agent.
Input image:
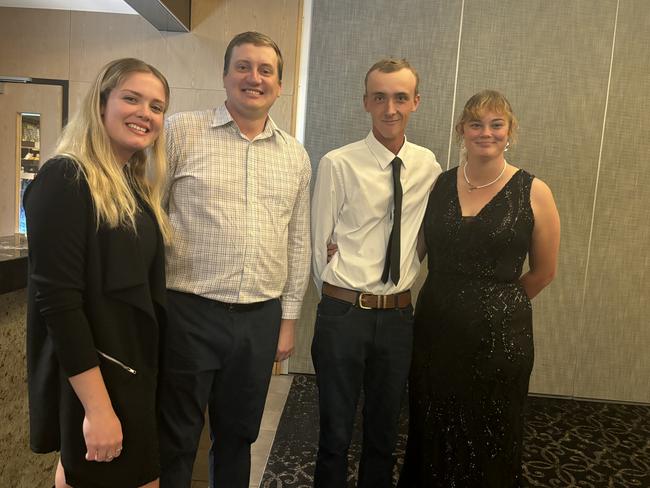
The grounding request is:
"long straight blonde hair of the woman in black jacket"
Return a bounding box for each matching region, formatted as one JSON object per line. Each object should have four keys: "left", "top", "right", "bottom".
{"left": 56, "top": 58, "right": 171, "bottom": 243}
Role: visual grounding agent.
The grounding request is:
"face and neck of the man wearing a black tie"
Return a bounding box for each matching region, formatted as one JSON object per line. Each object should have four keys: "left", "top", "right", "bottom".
{"left": 363, "top": 68, "right": 420, "bottom": 154}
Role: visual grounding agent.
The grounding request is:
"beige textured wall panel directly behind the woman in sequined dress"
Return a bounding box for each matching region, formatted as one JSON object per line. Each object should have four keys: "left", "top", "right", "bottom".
{"left": 453, "top": 0, "right": 616, "bottom": 395}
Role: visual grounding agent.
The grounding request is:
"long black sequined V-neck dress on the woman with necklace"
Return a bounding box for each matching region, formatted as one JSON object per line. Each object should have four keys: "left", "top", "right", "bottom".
{"left": 398, "top": 168, "right": 533, "bottom": 488}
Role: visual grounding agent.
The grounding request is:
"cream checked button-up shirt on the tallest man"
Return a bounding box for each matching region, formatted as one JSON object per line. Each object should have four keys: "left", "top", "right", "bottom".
{"left": 165, "top": 105, "right": 311, "bottom": 319}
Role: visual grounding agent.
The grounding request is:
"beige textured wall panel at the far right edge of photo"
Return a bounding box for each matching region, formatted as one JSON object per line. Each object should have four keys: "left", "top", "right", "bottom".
{"left": 575, "top": 0, "right": 650, "bottom": 403}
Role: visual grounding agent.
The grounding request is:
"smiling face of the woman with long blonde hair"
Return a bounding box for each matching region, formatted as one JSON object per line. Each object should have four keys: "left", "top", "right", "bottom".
{"left": 102, "top": 72, "right": 166, "bottom": 162}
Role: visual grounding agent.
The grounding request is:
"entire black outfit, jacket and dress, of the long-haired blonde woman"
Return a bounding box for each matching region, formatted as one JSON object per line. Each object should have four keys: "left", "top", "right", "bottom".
{"left": 24, "top": 158, "right": 165, "bottom": 488}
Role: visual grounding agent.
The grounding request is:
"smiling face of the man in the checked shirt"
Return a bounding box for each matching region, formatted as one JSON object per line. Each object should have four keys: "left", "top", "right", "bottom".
{"left": 223, "top": 43, "right": 282, "bottom": 122}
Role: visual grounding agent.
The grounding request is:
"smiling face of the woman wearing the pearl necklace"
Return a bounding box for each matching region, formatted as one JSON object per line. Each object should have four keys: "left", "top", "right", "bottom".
{"left": 462, "top": 110, "right": 510, "bottom": 160}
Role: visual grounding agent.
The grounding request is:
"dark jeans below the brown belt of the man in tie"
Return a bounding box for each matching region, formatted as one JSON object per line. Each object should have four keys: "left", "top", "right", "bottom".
{"left": 312, "top": 296, "right": 413, "bottom": 488}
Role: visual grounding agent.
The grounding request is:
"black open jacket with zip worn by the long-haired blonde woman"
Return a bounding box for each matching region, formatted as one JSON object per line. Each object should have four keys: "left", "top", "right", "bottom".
{"left": 24, "top": 158, "right": 165, "bottom": 452}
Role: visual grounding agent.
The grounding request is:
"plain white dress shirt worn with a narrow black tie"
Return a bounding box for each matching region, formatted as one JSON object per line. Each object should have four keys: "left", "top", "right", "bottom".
{"left": 312, "top": 132, "right": 441, "bottom": 295}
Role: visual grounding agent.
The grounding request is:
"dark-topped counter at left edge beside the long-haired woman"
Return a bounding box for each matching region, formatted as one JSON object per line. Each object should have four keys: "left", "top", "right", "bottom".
{"left": 0, "top": 236, "right": 56, "bottom": 488}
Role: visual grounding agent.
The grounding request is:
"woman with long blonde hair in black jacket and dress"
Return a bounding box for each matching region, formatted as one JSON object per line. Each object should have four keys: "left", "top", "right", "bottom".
{"left": 24, "top": 58, "right": 169, "bottom": 488}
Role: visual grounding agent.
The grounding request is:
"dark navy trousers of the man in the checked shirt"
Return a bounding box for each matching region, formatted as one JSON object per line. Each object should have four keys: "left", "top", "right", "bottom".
{"left": 158, "top": 291, "right": 282, "bottom": 488}
